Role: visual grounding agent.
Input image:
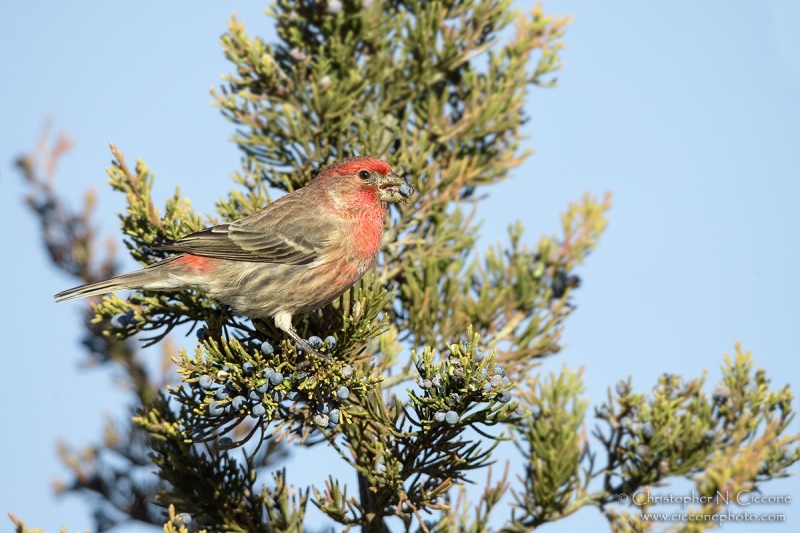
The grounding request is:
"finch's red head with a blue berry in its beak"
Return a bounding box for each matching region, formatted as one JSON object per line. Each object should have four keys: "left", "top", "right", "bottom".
{"left": 312, "top": 156, "right": 414, "bottom": 209}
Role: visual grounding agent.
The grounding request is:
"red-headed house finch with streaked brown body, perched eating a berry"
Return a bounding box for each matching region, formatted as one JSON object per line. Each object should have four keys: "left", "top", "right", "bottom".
{"left": 55, "top": 157, "right": 414, "bottom": 353}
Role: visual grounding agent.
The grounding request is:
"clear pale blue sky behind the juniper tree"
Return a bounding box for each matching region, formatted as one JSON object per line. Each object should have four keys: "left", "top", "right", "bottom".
{"left": 0, "top": 0, "right": 800, "bottom": 531}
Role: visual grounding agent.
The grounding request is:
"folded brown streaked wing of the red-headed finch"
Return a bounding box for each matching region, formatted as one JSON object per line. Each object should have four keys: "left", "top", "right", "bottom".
{"left": 153, "top": 189, "right": 337, "bottom": 265}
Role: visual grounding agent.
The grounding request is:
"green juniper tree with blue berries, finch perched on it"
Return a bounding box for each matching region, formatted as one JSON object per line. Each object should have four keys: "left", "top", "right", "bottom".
{"left": 9, "top": 0, "right": 800, "bottom": 533}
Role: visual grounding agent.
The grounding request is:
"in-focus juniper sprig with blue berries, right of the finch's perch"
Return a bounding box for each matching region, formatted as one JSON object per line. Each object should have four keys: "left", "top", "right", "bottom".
{"left": 315, "top": 332, "right": 514, "bottom": 528}
